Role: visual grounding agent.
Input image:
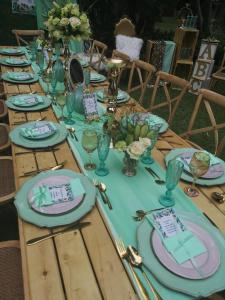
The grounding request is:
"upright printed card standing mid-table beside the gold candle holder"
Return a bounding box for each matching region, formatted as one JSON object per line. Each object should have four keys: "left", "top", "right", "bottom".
{"left": 83, "top": 93, "right": 99, "bottom": 120}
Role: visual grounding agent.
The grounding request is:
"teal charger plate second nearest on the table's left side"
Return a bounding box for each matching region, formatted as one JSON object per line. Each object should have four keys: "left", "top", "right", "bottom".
{"left": 9, "top": 121, "right": 68, "bottom": 149}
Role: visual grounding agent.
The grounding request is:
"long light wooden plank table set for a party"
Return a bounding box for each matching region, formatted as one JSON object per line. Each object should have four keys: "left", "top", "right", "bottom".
{"left": 1, "top": 49, "right": 225, "bottom": 300}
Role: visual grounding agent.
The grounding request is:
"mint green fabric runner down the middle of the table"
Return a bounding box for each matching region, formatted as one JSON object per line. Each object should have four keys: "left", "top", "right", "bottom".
{"left": 50, "top": 102, "right": 208, "bottom": 300}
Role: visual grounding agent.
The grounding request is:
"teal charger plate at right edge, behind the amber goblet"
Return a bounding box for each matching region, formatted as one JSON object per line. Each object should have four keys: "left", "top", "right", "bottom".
{"left": 165, "top": 148, "right": 225, "bottom": 186}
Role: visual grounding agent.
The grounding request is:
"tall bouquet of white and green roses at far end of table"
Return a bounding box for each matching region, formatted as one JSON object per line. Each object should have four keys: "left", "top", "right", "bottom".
{"left": 45, "top": 2, "right": 91, "bottom": 41}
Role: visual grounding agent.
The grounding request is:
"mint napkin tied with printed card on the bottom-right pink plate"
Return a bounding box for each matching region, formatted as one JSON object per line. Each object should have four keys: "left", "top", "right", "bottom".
{"left": 146, "top": 208, "right": 207, "bottom": 264}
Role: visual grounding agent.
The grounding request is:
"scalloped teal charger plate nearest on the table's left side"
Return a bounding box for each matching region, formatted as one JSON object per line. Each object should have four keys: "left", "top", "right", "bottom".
{"left": 14, "top": 169, "right": 96, "bottom": 227}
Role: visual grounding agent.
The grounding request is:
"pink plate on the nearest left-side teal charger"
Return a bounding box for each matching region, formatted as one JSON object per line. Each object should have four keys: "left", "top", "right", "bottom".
{"left": 28, "top": 175, "right": 84, "bottom": 215}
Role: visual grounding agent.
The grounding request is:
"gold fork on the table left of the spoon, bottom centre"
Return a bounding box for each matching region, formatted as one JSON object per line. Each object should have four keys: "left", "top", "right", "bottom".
{"left": 115, "top": 239, "right": 150, "bottom": 300}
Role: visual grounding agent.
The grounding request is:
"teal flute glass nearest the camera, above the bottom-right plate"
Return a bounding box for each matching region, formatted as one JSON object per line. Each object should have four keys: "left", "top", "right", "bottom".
{"left": 159, "top": 159, "right": 184, "bottom": 207}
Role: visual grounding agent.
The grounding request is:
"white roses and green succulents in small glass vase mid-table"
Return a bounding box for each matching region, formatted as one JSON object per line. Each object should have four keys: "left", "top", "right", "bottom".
{"left": 104, "top": 113, "right": 155, "bottom": 176}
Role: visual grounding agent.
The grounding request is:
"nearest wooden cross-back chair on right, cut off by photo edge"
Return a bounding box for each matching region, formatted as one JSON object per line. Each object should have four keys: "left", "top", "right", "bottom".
{"left": 181, "top": 89, "right": 225, "bottom": 154}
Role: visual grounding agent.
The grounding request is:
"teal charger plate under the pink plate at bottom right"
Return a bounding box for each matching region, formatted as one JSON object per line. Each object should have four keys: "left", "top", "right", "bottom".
{"left": 137, "top": 212, "right": 225, "bottom": 300}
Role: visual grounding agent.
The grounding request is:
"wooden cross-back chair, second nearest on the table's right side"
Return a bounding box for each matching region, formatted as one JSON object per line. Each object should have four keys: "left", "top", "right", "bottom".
{"left": 149, "top": 71, "right": 190, "bottom": 124}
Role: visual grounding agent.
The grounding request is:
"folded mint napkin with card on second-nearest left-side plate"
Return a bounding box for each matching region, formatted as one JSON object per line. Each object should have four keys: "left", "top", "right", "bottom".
{"left": 20, "top": 122, "right": 57, "bottom": 138}
